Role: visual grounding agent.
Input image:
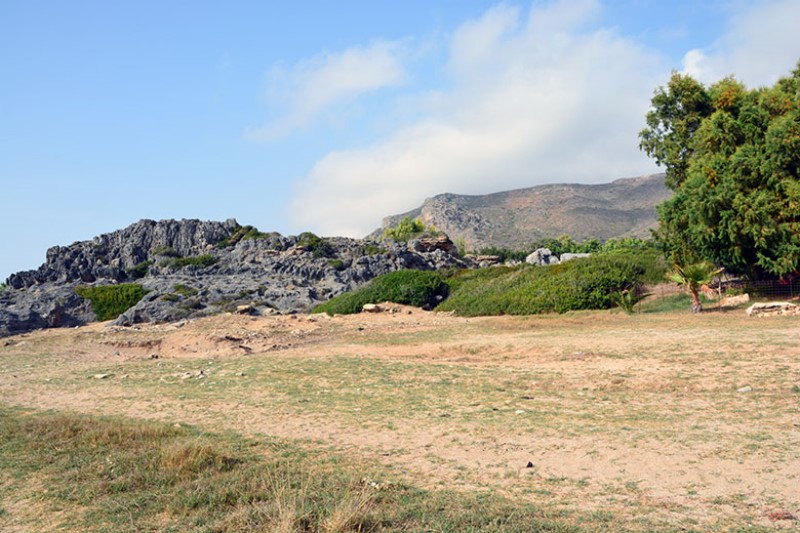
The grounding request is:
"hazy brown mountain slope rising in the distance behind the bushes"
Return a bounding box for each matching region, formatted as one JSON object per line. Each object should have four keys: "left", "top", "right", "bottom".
{"left": 379, "top": 174, "right": 672, "bottom": 250}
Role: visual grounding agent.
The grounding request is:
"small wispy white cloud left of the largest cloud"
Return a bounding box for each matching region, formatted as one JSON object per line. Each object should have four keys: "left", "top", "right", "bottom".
{"left": 247, "top": 41, "right": 406, "bottom": 140}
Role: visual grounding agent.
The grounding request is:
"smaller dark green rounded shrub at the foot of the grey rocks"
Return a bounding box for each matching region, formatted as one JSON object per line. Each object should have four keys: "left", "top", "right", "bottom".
{"left": 313, "top": 270, "right": 448, "bottom": 315}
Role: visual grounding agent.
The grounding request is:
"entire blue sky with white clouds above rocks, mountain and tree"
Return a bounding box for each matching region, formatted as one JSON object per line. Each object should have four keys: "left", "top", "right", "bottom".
{"left": 0, "top": 0, "right": 800, "bottom": 280}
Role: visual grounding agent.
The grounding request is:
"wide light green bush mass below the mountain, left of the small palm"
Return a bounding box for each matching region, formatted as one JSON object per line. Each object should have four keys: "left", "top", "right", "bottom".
{"left": 437, "top": 252, "right": 665, "bottom": 316}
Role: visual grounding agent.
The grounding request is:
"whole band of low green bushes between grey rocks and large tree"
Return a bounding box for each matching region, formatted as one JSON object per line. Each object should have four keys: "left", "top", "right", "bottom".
{"left": 314, "top": 251, "right": 666, "bottom": 316}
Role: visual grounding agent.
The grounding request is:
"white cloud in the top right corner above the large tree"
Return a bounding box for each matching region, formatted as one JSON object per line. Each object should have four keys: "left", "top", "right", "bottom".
{"left": 683, "top": 0, "right": 800, "bottom": 86}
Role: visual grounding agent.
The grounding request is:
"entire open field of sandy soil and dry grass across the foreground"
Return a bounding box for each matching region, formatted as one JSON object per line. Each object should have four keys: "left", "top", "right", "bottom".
{"left": 0, "top": 307, "right": 800, "bottom": 531}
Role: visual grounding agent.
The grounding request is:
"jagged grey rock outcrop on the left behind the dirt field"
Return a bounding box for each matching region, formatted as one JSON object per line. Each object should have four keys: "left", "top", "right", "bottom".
{"left": 0, "top": 219, "right": 466, "bottom": 336}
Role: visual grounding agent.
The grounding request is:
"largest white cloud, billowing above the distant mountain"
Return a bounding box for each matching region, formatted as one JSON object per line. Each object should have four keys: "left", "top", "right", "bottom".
{"left": 290, "top": 0, "right": 664, "bottom": 236}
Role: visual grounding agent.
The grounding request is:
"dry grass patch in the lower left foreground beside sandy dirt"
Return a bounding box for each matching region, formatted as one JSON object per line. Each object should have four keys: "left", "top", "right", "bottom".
{"left": 0, "top": 408, "right": 604, "bottom": 533}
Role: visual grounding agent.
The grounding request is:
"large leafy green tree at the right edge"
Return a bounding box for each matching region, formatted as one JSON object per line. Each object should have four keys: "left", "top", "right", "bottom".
{"left": 640, "top": 63, "right": 800, "bottom": 278}
